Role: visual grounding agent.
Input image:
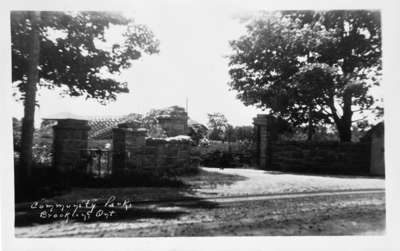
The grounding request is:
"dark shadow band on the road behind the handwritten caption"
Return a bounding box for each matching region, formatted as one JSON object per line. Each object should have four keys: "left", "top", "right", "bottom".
{"left": 15, "top": 188, "right": 219, "bottom": 227}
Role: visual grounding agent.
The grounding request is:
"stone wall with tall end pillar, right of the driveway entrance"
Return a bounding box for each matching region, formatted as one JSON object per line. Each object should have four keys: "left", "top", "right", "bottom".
{"left": 254, "top": 115, "right": 383, "bottom": 174}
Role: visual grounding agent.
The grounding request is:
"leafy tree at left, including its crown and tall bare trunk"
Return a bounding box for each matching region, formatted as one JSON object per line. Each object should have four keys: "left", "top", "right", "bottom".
{"left": 11, "top": 11, "right": 158, "bottom": 176}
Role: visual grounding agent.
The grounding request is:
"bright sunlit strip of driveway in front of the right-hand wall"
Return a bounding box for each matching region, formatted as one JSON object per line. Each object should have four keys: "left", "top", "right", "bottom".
{"left": 196, "top": 168, "right": 385, "bottom": 197}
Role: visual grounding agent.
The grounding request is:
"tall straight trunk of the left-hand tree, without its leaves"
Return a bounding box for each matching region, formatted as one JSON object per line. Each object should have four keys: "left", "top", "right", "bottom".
{"left": 19, "top": 11, "right": 40, "bottom": 178}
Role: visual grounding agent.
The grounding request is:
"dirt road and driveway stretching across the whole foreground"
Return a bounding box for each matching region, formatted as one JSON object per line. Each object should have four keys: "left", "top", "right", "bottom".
{"left": 15, "top": 168, "right": 385, "bottom": 237}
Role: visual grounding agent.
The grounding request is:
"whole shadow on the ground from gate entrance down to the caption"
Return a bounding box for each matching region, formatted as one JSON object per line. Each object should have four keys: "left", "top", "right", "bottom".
{"left": 15, "top": 167, "right": 244, "bottom": 227}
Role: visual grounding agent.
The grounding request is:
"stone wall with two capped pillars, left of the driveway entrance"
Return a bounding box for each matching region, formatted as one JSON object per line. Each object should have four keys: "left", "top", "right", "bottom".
{"left": 53, "top": 116, "right": 192, "bottom": 176}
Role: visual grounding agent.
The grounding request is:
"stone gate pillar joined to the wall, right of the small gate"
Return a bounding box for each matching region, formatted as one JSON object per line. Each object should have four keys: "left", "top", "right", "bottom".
{"left": 112, "top": 124, "right": 147, "bottom": 174}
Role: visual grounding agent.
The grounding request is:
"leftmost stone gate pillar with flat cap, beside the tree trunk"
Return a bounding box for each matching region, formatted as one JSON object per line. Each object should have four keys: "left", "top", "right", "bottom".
{"left": 53, "top": 119, "right": 90, "bottom": 172}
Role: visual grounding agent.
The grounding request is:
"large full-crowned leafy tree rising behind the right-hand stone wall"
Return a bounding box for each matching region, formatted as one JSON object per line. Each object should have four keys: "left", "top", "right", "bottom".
{"left": 229, "top": 10, "right": 381, "bottom": 141}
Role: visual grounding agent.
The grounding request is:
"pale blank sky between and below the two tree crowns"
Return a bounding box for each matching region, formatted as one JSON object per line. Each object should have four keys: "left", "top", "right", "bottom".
{"left": 13, "top": 3, "right": 262, "bottom": 126}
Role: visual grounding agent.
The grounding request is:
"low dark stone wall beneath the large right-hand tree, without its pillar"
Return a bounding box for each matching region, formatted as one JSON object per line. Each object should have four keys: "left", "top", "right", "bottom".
{"left": 267, "top": 141, "right": 370, "bottom": 174}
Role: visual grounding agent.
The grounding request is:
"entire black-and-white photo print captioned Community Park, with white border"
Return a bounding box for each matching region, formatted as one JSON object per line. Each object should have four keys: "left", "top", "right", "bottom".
{"left": 2, "top": 1, "right": 400, "bottom": 250}
